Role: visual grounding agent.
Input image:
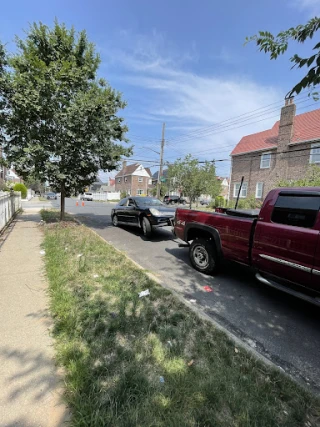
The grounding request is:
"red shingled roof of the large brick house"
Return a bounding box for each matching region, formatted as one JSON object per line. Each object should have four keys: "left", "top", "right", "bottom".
{"left": 231, "top": 108, "right": 320, "bottom": 156}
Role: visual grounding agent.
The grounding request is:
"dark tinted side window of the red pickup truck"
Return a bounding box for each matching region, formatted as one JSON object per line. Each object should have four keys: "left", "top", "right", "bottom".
{"left": 271, "top": 195, "right": 320, "bottom": 228}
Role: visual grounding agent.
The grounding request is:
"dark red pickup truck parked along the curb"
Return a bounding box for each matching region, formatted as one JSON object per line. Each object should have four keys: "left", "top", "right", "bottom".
{"left": 174, "top": 187, "right": 320, "bottom": 305}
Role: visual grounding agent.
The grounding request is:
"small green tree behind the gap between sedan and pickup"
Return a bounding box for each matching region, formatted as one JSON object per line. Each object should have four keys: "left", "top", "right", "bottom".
{"left": 167, "top": 154, "right": 221, "bottom": 208}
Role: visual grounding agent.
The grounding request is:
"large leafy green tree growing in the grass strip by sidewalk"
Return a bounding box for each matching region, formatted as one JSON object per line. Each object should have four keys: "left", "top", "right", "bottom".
{"left": 0, "top": 21, "right": 131, "bottom": 220}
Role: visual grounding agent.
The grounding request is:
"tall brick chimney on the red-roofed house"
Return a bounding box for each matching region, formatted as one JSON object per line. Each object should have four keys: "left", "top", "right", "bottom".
{"left": 277, "top": 97, "right": 296, "bottom": 152}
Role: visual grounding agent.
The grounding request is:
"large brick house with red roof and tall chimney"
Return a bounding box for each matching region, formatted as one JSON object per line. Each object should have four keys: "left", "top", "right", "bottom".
{"left": 230, "top": 98, "right": 320, "bottom": 200}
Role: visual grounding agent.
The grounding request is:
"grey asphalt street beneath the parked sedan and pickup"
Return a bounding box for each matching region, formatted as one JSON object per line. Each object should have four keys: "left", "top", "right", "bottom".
{"left": 25, "top": 199, "right": 320, "bottom": 392}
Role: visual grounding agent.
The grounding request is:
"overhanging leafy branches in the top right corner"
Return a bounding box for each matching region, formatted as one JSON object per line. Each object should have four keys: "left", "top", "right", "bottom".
{"left": 246, "top": 17, "right": 320, "bottom": 99}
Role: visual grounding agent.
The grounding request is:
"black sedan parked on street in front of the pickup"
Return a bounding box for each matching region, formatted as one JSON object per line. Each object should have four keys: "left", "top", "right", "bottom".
{"left": 111, "top": 197, "right": 176, "bottom": 237}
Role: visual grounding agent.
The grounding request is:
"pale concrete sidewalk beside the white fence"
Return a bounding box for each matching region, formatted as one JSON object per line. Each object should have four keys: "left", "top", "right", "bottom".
{"left": 0, "top": 209, "right": 68, "bottom": 427}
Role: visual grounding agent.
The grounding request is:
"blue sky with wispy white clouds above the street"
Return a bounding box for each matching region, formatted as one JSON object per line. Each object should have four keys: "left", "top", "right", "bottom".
{"left": 0, "top": 0, "right": 320, "bottom": 179}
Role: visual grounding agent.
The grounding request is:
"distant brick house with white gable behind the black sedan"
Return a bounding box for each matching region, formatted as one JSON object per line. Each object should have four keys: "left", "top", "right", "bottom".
{"left": 115, "top": 161, "right": 152, "bottom": 196}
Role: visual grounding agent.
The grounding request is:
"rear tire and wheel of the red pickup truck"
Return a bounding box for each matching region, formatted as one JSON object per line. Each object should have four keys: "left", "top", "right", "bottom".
{"left": 189, "top": 238, "right": 218, "bottom": 274}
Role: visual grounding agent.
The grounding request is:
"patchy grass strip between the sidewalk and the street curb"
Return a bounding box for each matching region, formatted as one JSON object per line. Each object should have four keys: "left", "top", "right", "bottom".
{"left": 42, "top": 211, "right": 320, "bottom": 427}
